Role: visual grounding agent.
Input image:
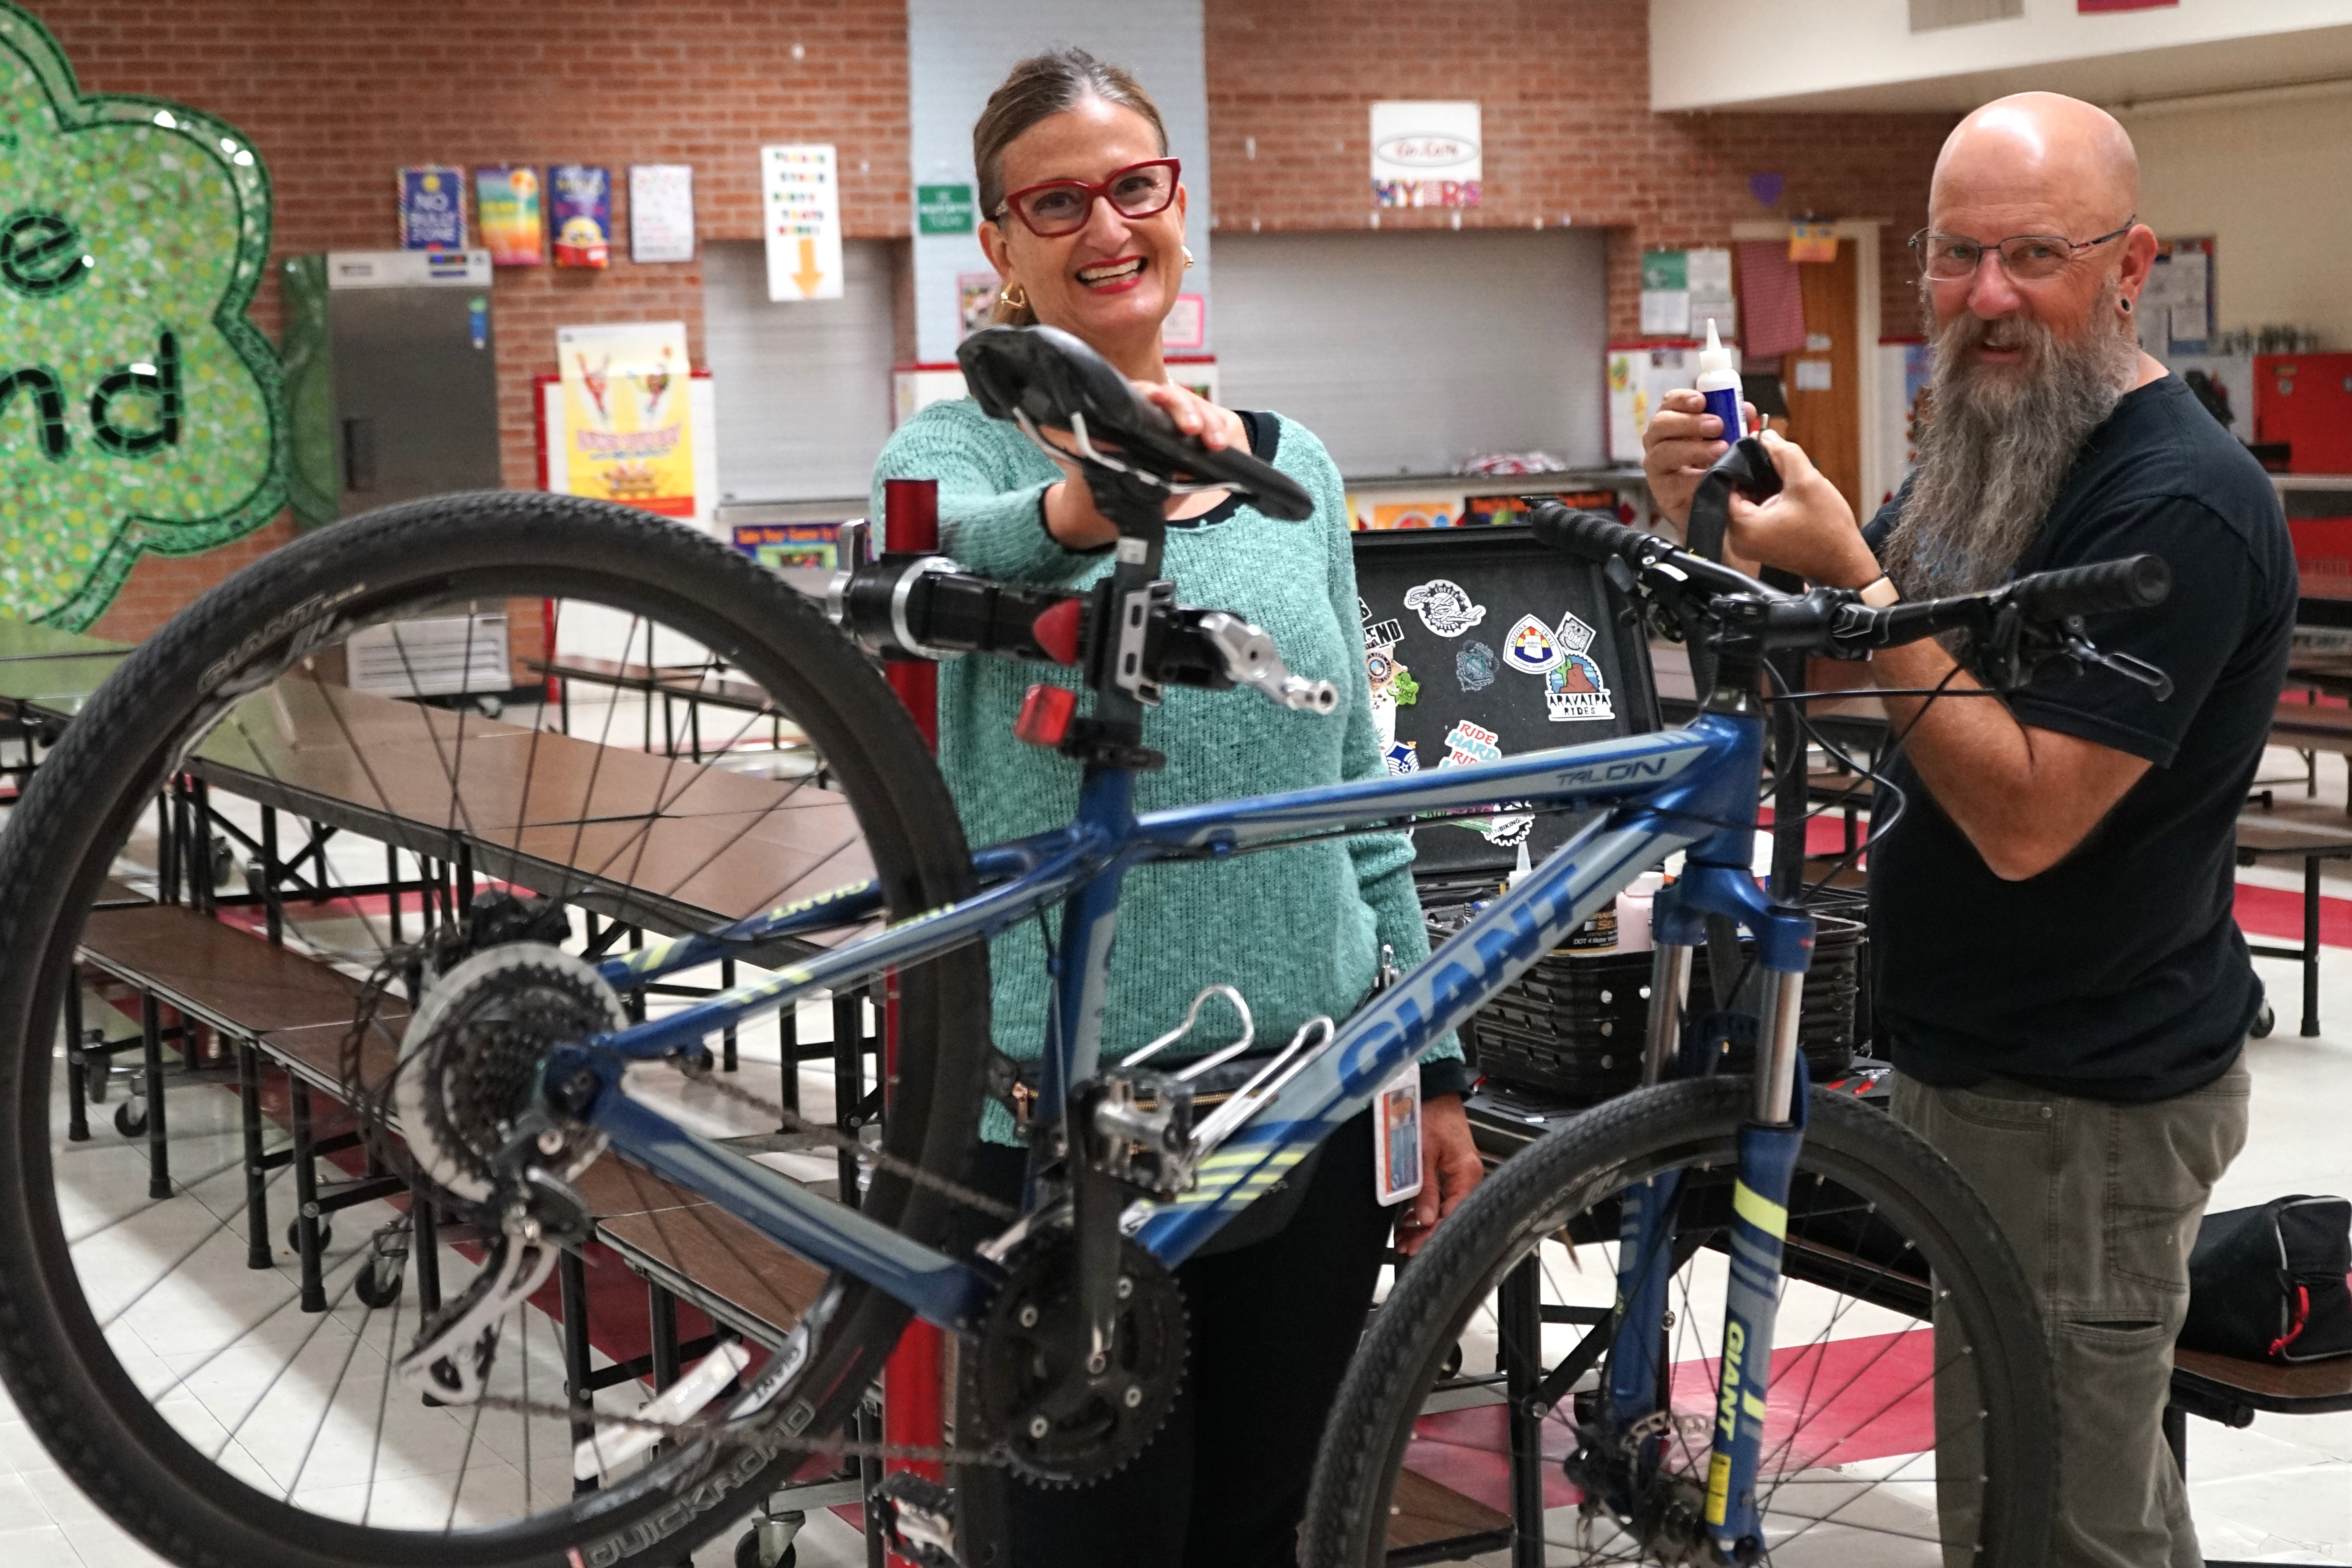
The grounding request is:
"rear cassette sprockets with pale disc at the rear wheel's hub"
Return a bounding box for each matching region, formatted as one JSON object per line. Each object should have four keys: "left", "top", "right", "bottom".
{"left": 391, "top": 943, "right": 628, "bottom": 1204}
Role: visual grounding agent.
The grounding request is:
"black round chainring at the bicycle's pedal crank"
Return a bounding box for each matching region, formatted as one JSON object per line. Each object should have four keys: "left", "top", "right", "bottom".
{"left": 974, "top": 1229, "right": 1185, "bottom": 1488}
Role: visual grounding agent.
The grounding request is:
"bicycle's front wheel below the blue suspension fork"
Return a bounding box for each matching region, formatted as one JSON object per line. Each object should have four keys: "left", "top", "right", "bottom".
{"left": 1303, "top": 1079, "right": 2055, "bottom": 1568}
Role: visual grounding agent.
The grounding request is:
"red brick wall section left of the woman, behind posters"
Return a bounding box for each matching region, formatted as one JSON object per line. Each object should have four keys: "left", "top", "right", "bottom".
{"left": 31, "top": 0, "right": 910, "bottom": 637}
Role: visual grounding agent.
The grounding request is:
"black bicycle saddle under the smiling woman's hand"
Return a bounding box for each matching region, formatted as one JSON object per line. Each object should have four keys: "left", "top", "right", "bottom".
{"left": 955, "top": 327, "right": 1315, "bottom": 522}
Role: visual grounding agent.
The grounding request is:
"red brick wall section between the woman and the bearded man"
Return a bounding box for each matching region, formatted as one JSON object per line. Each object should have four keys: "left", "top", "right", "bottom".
{"left": 1204, "top": 0, "right": 1957, "bottom": 339}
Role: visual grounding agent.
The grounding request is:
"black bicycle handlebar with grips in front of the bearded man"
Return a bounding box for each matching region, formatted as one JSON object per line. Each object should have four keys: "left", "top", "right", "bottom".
{"left": 1529, "top": 503, "right": 2173, "bottom": 698}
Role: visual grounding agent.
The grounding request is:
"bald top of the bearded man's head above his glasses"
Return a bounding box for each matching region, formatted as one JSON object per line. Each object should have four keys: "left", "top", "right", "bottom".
{"left": 1929, "top": 92, "right": 2140, "bottom": 240}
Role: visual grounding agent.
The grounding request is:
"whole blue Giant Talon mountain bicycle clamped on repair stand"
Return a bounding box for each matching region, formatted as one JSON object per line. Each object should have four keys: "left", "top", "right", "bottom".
{"left": 0, "top": 329, "right": 2164, "bottom": 1568}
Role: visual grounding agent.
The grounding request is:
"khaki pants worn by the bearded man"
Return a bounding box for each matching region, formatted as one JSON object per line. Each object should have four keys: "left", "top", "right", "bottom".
{"left": 1894, "top": 1056, "right": 2253, "bottom": 1568}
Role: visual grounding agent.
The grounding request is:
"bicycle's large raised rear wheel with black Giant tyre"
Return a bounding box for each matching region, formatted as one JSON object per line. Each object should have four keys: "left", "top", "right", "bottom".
{"left": 0, "top": 494, "right": 988, "bottom": 1568}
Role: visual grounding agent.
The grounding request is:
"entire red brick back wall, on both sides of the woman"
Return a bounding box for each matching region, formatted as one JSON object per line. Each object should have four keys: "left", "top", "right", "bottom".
{"left": 35, "top": 0, "right": 1952, "bottom": 637}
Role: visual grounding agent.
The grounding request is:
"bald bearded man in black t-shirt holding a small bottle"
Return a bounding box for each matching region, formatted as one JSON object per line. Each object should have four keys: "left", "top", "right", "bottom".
{"left": 1644, "top": 94, "right": 2296, "bottom": 1568}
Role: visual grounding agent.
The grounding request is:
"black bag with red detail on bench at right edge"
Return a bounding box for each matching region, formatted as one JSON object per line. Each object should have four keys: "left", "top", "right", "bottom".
{"left": 2180, "top": 1192, "right": 2352, "bottom": 1361}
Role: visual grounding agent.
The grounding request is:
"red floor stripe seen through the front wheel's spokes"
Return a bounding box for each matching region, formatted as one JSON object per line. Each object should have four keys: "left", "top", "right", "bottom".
{"left": 1404, "top": 1328, "right": 1936, "bottom": 1512}
